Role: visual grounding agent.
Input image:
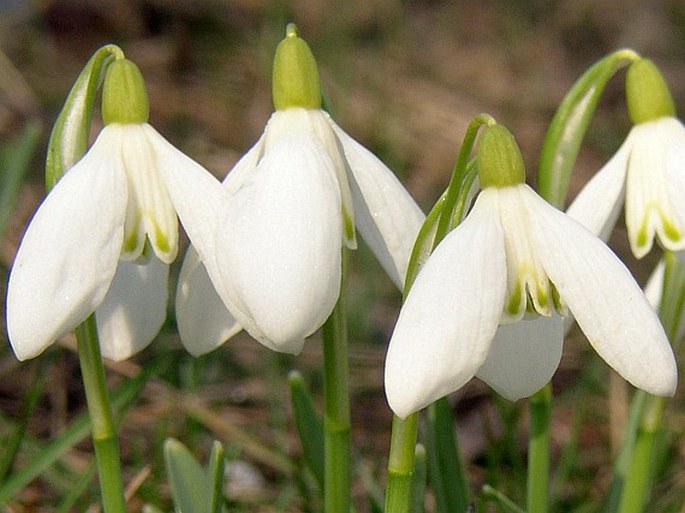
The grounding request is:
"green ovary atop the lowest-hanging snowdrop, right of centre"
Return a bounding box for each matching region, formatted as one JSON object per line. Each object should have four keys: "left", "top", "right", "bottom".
{"left": 476, "top": 125, "right": 526, "bottom": 189}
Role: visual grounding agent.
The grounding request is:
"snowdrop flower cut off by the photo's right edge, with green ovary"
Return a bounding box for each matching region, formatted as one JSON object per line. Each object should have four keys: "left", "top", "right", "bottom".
{"left": 567, "top": 59, "right": 685, "bottom": 258}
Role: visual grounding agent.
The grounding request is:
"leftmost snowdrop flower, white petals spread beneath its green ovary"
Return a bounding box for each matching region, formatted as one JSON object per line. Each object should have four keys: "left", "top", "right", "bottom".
{"left": 7, "top": 57, "right": 221, "bottom": 360}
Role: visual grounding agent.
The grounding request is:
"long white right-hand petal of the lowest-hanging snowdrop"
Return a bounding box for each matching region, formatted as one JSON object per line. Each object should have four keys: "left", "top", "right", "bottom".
{"left": 526, "top": 186, "right": 677, "bottom": 395}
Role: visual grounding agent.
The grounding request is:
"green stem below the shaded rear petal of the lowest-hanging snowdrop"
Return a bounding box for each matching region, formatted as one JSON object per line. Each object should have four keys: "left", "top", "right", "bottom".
{"left": 528, "top": 383, "right": 552, "bottom": 513}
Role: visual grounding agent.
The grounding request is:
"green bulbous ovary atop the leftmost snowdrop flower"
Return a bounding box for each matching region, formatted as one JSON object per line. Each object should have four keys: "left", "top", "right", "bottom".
{"left": 102, "top": 58, "right": 150, "bottom": 125}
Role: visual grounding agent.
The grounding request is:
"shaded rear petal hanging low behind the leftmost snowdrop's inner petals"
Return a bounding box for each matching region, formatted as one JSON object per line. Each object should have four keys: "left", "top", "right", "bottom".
{"left": 95, "top": 255, "right": 169, "bottom": 361}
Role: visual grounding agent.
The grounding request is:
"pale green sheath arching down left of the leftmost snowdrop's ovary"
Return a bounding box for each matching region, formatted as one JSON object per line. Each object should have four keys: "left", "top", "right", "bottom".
{"left": 45, "top": 45, "right": 124, "bottom": 190}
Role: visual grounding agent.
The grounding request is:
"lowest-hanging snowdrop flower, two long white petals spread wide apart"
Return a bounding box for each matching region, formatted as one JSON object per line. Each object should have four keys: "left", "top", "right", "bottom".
{"left": 385, "top": 125, "right": 677, "bottom": 417}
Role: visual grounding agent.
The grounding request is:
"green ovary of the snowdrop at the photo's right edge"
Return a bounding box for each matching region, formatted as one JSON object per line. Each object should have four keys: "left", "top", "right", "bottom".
{"left": 626, "top": 59, "right": 675, "bottom": 125}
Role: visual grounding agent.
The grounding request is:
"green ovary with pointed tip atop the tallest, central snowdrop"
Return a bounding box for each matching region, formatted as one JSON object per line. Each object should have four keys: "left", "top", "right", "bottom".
{"left": 272, "top": 23, "right": 321, "bottom": 110}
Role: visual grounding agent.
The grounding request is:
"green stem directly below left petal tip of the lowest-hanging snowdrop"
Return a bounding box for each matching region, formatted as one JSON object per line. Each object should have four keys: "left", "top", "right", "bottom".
{"left": 385, "top": 413, "right": 419, "bottom": 513}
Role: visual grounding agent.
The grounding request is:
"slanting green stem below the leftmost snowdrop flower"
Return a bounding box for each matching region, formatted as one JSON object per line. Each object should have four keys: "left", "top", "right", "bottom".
{"left": 75, "top": 315, "right": 126, "bottom": 513}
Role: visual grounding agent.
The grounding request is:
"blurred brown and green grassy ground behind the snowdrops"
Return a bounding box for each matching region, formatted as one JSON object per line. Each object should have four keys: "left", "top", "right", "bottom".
{"left": 0, "top": 0, "right": 685, "bottom": 512}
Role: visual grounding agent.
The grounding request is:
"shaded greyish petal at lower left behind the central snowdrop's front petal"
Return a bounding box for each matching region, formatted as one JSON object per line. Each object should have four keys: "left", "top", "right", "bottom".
{"left": 176, "top": 246, "right": 242, "bottom": 356}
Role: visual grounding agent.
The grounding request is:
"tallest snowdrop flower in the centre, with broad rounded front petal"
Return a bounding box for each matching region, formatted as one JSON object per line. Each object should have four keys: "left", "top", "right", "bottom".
{"left": 176, "top": 25, "right": 424, "bottom": 354}
